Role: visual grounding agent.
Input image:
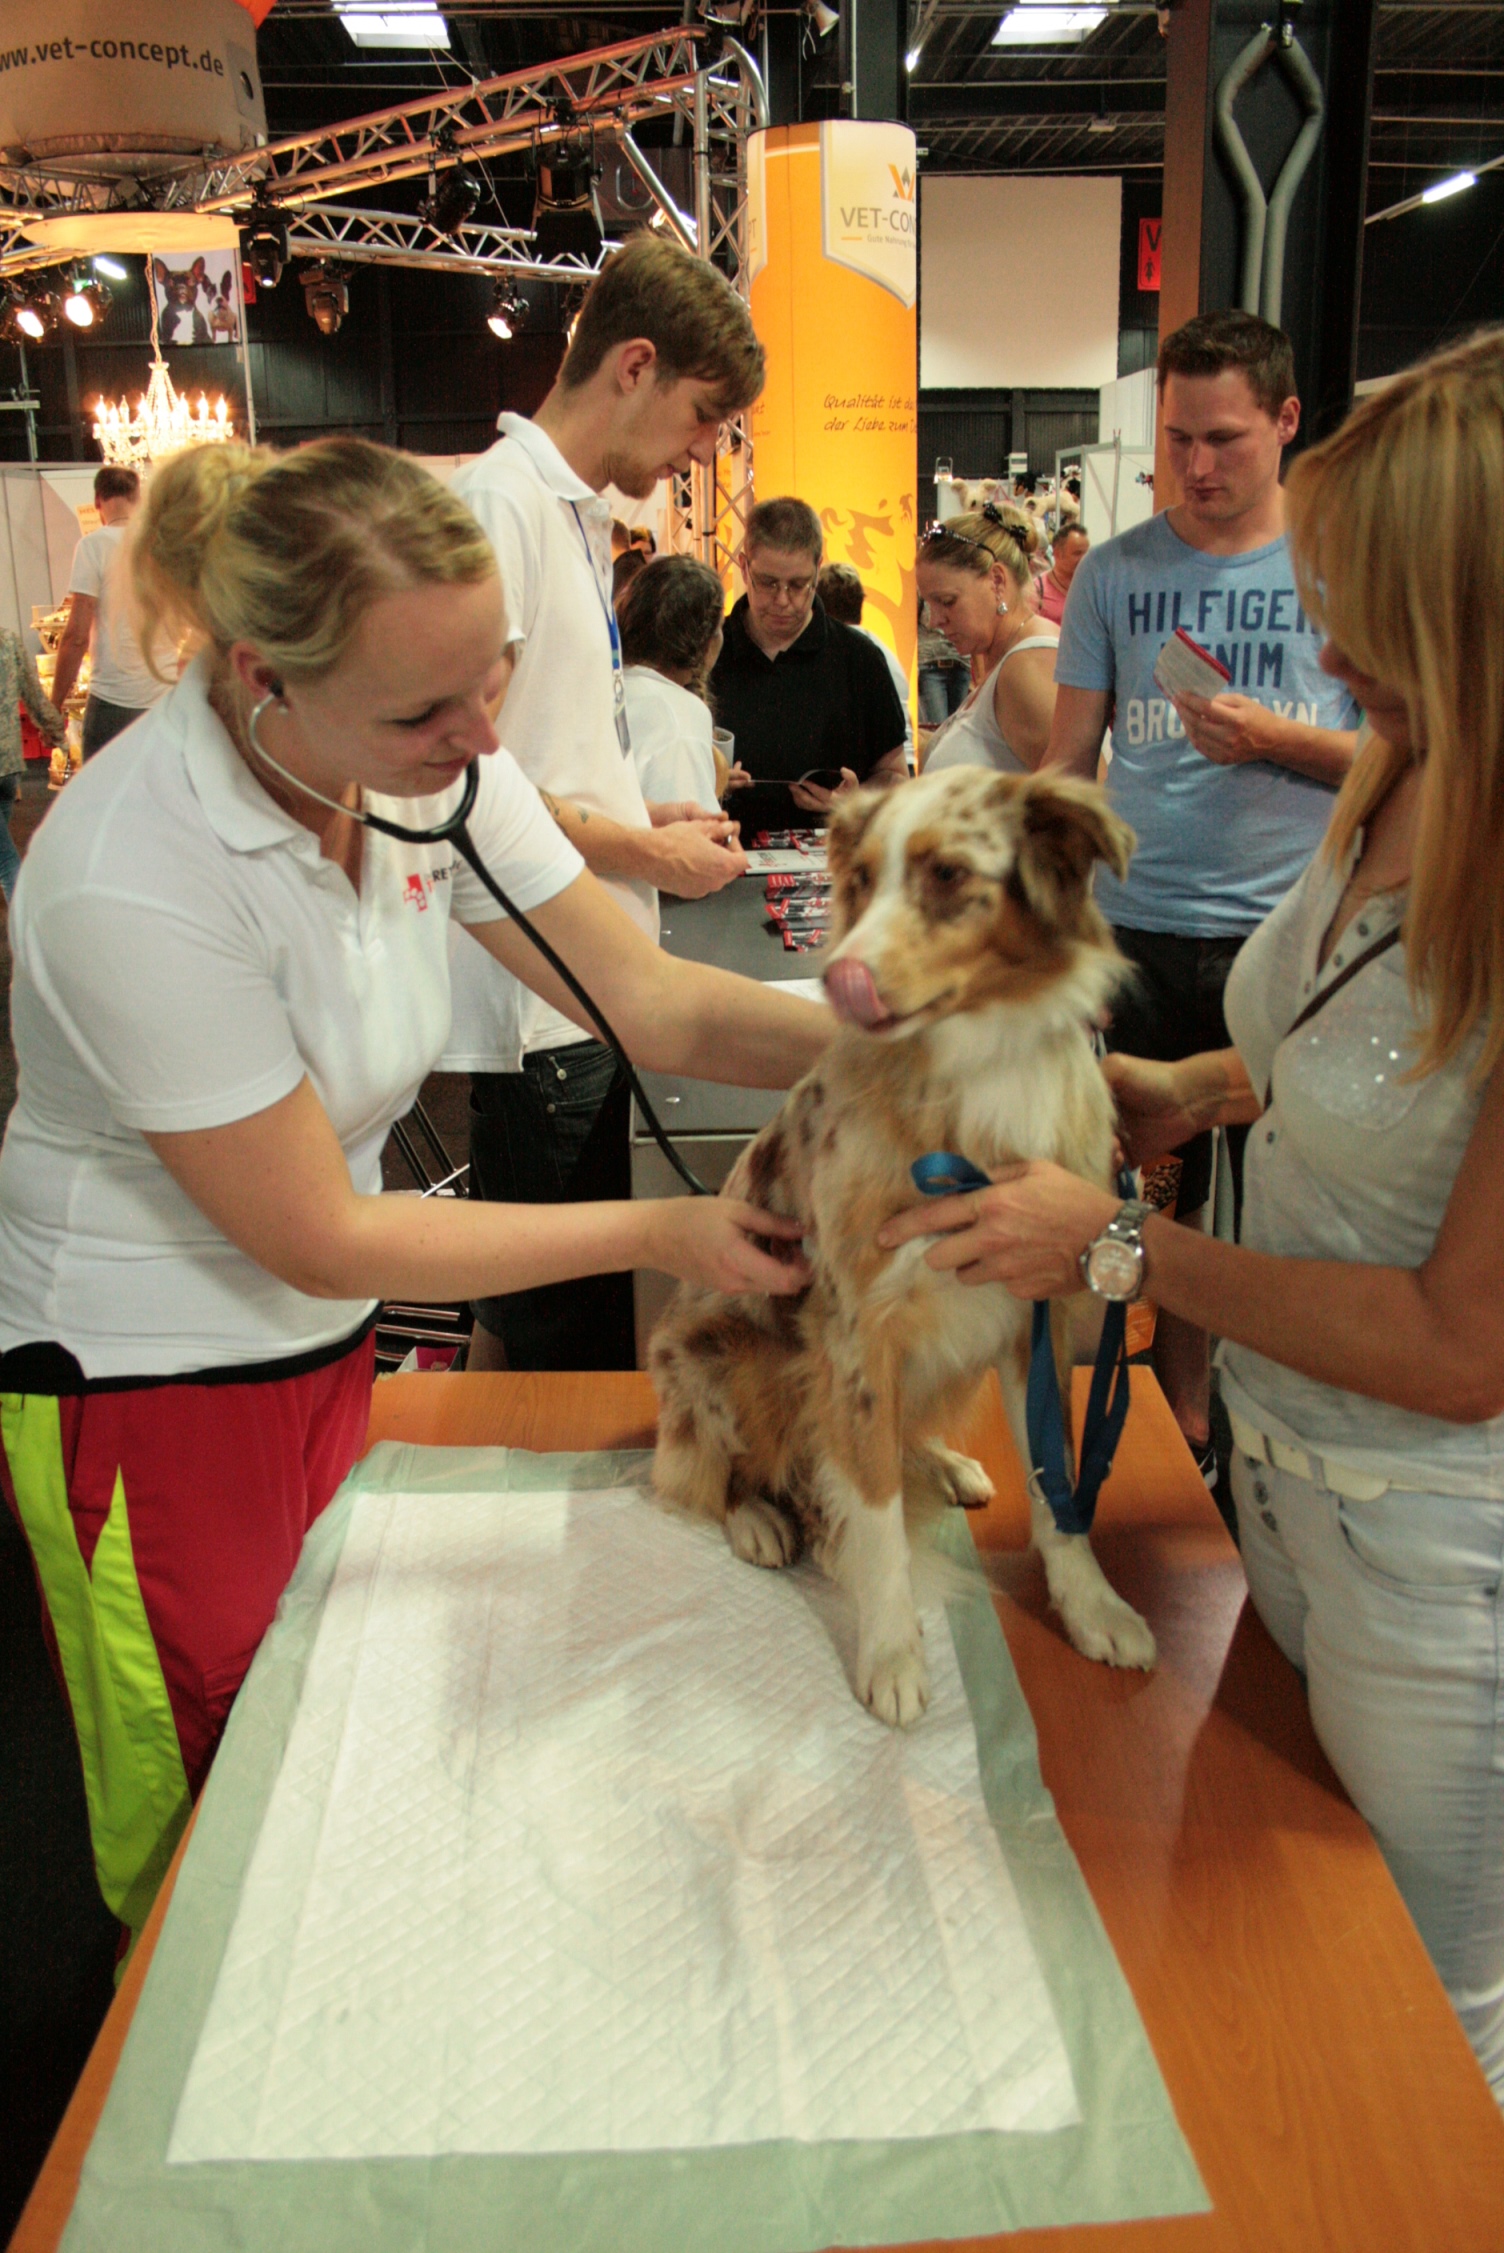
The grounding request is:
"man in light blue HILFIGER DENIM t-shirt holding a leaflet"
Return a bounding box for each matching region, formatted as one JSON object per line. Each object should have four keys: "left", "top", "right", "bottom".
{"left": 1045, "top": 313, "right": 1358, "bottom": 1464}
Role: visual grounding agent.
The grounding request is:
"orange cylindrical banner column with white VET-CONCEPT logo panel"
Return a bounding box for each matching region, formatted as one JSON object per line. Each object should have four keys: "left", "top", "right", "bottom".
{"left": 747, "top": 119, "right": 919, "bottom": 698}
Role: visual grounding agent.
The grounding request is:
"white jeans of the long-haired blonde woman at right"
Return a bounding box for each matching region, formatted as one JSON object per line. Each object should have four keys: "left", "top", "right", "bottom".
{"left": 1232, "top": 1451, "right": 1504, "bottom": 2104}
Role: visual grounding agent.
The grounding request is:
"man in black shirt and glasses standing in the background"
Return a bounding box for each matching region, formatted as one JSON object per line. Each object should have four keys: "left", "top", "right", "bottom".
{"left": 709, "top": 500, "right": 907, "bottom": 838}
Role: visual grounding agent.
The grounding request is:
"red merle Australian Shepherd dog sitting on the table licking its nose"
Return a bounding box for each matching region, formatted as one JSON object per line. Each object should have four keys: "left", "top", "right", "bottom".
{"left": 648, "top": 768, "right": 1155, "bottom": 1724}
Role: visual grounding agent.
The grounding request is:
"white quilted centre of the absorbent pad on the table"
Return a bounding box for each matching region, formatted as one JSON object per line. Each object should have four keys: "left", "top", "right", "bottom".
{"left": 167, "top": 1489, "right": 1081, "bottom": 2163}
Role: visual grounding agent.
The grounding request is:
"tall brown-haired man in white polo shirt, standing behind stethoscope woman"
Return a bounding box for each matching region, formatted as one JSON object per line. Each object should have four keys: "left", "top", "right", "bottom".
{"left": 444, "top": 234, "right": 763, "bottom": 1370}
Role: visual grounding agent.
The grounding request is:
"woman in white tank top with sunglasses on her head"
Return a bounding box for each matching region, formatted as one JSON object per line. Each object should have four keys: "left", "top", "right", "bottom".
{"left": 919, "top": 502, "right": 1060, "bottom": 775}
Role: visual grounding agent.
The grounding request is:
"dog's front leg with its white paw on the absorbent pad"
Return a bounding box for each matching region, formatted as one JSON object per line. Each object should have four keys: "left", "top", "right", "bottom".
{"left": 817, "top": 1329, "right": 930, "bottom": 1728}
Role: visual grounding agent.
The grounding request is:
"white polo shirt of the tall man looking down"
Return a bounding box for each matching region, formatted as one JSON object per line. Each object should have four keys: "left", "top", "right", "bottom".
{"left": 444, "top": 415, "right": 657, "bottom": 1072}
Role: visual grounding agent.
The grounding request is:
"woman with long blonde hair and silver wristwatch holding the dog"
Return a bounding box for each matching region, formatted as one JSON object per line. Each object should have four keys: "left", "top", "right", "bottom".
{"left": 873, "top": 331, "right": 1504, "bottom": 2100}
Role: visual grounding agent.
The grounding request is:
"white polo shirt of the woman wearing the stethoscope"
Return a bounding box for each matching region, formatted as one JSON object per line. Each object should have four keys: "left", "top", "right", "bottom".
{"left": 0, "top": 660, "right": 583, "bottom": 1377}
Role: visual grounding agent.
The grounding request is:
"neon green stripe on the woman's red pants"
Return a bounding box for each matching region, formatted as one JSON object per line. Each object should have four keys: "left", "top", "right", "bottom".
{"left": 0, "top": 1392, "right": 189, "bottom": 1933}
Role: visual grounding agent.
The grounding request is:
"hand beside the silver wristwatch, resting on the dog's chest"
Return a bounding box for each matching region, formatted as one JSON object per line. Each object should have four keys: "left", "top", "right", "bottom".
{"left": 878, "top": 1165, "right": 1121, "bottom": 1298}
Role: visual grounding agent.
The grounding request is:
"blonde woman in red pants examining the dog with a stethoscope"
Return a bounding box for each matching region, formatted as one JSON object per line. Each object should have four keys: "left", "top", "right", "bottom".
{"left": 0, "top": 439, "right": 824, "bottom": 1929}
